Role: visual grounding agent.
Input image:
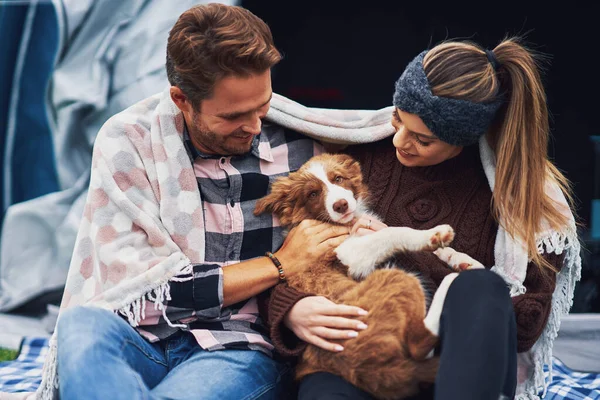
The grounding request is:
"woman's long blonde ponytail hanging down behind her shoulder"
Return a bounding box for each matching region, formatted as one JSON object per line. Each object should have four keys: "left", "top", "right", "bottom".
{"left": 489, "top": 39, "right": 573, "bottom": 270}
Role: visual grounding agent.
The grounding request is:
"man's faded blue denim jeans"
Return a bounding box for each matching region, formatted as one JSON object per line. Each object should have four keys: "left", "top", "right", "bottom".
{"left": 57, "top": 307, "right": 292, "bottom": 400}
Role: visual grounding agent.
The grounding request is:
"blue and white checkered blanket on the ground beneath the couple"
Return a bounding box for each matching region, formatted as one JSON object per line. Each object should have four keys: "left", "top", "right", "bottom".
{"left": 0, "top": 338, "right": 600, "bottom": 400}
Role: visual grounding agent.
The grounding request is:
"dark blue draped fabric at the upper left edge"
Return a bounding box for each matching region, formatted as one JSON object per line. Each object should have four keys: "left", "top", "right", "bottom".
{"left": 0, "top": 1, "right": 58, "bottom": 223}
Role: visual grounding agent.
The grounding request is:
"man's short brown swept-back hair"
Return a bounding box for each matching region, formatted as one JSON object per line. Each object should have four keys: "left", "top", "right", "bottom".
{"left": 167, "top": 3, "right": 281, "bottom": 111}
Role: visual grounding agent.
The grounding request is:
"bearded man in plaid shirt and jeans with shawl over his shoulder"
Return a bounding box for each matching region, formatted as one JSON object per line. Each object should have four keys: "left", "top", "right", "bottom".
{"left": 50, "top": 4, "right": 370, "bottom": 400}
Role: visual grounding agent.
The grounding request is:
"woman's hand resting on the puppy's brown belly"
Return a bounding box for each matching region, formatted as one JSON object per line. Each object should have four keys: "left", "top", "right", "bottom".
{"left": 283, "top": 296, "right": 367, "bottom": 352}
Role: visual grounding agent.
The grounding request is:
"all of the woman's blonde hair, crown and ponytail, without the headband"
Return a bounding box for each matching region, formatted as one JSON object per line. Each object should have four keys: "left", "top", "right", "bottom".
{"left": 423, "top": 38, "right": 573, "bottom": 271}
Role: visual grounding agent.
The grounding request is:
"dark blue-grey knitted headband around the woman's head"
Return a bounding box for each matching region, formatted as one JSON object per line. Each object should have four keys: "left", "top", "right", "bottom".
{"left": 394, "top": 50, "right": 502, "bottom": 146}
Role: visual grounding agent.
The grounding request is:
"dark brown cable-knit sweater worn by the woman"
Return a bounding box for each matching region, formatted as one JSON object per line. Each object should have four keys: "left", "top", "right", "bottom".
{"left": 262, "top": 138, "right": 563, "bottom": 356}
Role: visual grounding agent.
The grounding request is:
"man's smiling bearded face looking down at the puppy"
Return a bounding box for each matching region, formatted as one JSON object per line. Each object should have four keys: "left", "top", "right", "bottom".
{"left": 184, "top": 70, "right": 273, "bottom": 155}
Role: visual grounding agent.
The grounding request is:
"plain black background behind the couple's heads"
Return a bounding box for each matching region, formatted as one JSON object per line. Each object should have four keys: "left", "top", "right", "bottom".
{"left": 241, "top": 0, "right": 600, "bottom": 312}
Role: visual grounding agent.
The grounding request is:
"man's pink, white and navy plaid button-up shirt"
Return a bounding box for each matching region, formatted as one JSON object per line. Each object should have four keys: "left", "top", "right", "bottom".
{"left": 138, "top": 123, "right": 322, "bottom": 354}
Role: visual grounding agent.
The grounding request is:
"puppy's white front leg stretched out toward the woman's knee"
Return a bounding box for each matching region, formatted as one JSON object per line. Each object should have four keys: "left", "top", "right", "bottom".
{"left": 335, "top": 225, "right": 454, "bottom": 279}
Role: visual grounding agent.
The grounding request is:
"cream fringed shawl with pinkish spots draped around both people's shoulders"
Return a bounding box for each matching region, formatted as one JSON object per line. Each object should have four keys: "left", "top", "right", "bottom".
{"left": 25, "top": 90, "right": 581, "bottom": 399}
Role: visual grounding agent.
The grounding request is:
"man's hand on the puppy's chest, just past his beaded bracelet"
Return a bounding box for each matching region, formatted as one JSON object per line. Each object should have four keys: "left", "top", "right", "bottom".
{"left": 275, "top": 220, "right": 350, "bottom": 277}
